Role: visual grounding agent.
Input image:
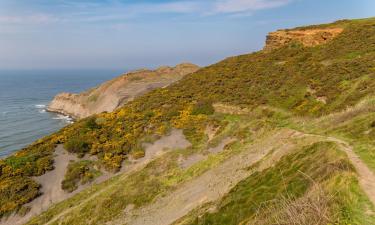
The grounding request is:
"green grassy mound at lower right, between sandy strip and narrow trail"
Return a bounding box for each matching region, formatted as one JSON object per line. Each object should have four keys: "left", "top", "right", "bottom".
{"left": 180, "top": 142, "right": 375, "bottom": 225}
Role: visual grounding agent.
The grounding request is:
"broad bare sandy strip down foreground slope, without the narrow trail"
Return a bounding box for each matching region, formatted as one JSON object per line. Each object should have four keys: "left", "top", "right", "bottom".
{"left": 107, "top": 130, "right": 306, "bottom": 225}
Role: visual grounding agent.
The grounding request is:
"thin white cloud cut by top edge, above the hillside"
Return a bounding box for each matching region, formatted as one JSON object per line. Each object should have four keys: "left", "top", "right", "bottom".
{"left": 213, "top": 0, "right": 292, "bottom": 13}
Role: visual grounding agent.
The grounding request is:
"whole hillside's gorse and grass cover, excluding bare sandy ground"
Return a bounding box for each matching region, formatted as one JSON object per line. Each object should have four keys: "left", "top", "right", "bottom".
{"left": 0, "top": 19, "right": 375, "bottom": 224}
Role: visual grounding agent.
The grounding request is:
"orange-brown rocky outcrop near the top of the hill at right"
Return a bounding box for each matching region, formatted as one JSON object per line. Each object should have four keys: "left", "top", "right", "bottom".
{"left": 264, "top": 28, "right": 343, "bottom": 51}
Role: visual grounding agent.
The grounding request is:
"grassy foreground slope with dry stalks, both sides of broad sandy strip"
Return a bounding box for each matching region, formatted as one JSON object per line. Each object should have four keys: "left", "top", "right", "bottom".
{"left": 29, "top": 110, "right": 375, "bottom": 224}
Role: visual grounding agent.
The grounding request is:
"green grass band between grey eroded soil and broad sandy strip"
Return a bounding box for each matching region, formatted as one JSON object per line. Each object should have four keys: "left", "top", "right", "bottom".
{"left": 29, "top": 115, "right": 272, "bottom": 224}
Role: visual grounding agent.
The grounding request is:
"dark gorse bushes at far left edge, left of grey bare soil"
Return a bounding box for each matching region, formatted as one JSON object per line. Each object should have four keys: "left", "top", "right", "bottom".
{"left": 0, "top": 137, "right": 54, "bottom": 217}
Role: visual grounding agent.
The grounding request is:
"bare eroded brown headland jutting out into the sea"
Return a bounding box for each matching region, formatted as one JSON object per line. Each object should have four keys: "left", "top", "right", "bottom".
{"left": 48, "top": 63, "right": 199, "bottom": 119}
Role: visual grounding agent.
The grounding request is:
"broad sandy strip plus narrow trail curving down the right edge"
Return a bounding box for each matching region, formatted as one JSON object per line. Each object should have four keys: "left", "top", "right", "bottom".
{"left": 114, "top": 131, "right": 375, "bottom": 225}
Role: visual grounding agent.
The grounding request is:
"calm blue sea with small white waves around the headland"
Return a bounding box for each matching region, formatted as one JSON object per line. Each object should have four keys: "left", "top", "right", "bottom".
{"left": 0, "top": 70, "right": 121, "bottom": 158}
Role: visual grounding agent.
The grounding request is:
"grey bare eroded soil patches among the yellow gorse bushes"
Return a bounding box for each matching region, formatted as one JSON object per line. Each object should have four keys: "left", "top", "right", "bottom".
{"left": 0, "top": 130, "right": 191, "bottom": 225}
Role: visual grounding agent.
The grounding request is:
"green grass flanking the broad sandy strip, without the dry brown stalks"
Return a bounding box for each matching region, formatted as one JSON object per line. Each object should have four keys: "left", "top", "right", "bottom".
{"left": 30, "top": 109, "right": 374, "bottom": 224}
